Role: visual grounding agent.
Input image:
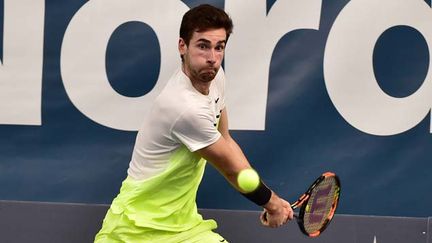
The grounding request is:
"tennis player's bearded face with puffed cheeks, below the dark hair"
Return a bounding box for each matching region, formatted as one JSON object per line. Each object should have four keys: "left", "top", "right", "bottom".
{"left": 179, "top": 28, "right": 226, "bottom": 82}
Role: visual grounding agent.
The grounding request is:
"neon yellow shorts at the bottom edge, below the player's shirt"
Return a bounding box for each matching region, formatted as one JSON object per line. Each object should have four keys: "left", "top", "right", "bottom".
{"left": 94, "top": 210, "right": 228, "bottom": 243}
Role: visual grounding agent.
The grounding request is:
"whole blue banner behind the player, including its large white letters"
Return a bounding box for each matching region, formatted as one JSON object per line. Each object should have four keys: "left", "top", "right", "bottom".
{"left": 0, "top": 0, "right": 432, "bottom": 217}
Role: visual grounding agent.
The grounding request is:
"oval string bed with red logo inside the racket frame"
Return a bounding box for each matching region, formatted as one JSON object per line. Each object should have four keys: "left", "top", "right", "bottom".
{"left": 303, "top": 177, "right": 338, "bottom": 234}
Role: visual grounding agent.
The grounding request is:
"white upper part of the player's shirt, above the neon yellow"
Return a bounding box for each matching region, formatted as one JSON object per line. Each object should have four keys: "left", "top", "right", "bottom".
{"left": 128, "top": 68, "right": 225, "bottom": 180}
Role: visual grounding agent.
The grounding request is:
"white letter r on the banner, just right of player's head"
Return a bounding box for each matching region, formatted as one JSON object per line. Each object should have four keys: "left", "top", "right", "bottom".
{"left": 225, "top": 0, "right": 321, "bottom": 130}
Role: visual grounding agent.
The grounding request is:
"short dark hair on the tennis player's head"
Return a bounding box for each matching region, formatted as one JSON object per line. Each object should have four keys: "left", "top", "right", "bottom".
{"left": 180, "top": 4, "right": 233, "bottom": 45}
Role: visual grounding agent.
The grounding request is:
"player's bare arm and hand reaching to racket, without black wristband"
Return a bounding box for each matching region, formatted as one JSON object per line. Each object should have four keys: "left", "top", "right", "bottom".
{"left": 198, "top": 109, "right": 293, "bottom": 227}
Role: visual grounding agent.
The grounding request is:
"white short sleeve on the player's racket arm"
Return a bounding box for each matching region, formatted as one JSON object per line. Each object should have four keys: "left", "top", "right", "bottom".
{"left": 172, "top": 105, "right": 221, "bottom": 152}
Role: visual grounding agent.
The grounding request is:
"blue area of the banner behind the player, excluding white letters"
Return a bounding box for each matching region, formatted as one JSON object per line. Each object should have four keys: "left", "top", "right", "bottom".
{"left": 0, "top": 0, "right": 432, "bottom": 216}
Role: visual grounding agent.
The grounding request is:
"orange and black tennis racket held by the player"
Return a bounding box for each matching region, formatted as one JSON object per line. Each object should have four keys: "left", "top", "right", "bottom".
{"left": 263, "top": 172, "right": 340, "bottom": 237}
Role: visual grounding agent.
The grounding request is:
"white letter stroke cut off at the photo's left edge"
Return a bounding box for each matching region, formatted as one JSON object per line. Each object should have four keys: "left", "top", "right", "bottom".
{"left": 0, "top": 0, "right": 45, "bottom": 125}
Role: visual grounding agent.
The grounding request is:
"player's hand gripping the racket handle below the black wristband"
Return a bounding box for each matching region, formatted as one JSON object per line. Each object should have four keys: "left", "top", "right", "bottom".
{"left": 260, "top": 192, "right": 294, "bottom": 228}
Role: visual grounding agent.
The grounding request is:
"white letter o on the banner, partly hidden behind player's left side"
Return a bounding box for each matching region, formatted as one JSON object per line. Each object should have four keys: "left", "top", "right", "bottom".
{"left": 61, "top": 0, "right": 189, "bottom": 131}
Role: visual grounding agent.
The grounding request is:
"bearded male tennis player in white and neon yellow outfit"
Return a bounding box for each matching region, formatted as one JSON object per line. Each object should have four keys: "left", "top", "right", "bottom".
{"left": 96, "top": 5, "right": 293, "bottom": 243}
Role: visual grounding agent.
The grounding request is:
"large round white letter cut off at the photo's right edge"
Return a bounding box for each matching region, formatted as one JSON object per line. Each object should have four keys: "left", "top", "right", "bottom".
{"left": 324, "top": 0, "right": 432, "bottom": 135}
